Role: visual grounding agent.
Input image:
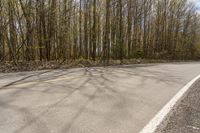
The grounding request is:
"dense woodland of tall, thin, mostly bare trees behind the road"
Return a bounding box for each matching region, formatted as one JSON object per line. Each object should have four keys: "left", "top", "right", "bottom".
{"left": 0, "top": 0, "right": 200, "bottom": 64}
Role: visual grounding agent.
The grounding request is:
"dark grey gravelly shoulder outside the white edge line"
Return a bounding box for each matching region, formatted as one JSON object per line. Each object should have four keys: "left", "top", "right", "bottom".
{"left": 156, "top": 79, "right": 200, "bottom": 133}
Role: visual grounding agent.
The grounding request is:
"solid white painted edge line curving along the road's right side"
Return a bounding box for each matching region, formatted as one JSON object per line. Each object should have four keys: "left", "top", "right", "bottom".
{"left": 140, "top": 75, "right": 200, "bottom": 133}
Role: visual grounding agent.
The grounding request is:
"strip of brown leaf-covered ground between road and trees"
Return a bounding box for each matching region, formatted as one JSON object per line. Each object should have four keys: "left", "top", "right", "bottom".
{"left": 0, "top": 59, "right": 169, "bottom": 73}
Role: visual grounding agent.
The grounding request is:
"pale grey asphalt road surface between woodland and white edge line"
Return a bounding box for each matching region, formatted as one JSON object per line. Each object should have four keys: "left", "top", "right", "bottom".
{"left": 0, "top": 63, "right": 200, "bottom": 133}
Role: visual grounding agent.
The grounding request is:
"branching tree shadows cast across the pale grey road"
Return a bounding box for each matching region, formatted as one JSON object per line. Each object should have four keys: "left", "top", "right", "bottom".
{"left": 0, "top": 65, "right": 186, "bottom": 133}
